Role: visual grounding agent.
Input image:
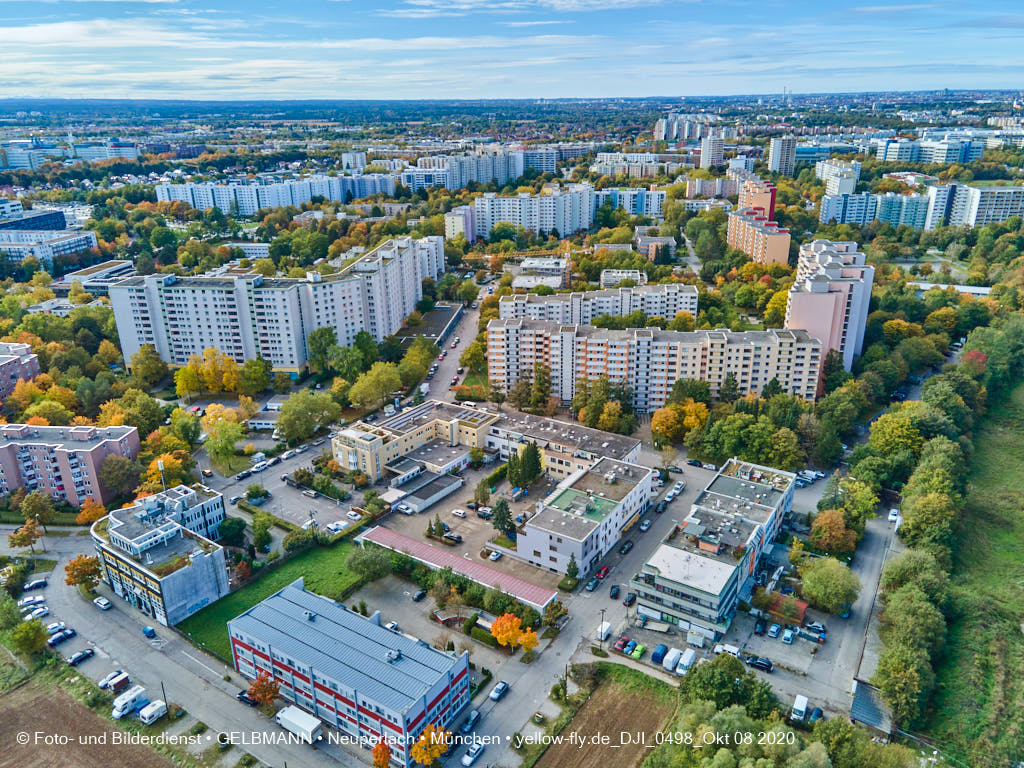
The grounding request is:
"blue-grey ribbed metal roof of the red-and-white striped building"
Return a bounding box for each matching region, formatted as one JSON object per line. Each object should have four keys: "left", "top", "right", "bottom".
{"left": 227, "top": 579, "right": 460, "bottom": 713}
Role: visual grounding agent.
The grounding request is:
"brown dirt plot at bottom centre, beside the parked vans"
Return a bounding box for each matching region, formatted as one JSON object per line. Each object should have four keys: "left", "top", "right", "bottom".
{"left": 537, "top": 683, "right": 672, "bottom": 768}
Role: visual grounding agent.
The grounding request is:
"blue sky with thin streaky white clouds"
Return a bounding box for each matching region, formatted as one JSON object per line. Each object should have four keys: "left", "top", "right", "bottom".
{"left": 0, "top": 0, "right": 1024, "bottom": 98}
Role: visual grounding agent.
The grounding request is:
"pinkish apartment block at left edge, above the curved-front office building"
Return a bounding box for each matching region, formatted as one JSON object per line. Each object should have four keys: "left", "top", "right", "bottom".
{"left": 0, "top": 424, "right": 139, "bottom": 507}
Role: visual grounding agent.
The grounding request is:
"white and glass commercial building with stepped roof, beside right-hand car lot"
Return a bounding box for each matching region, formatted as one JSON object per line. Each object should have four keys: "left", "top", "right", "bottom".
{"left": 629, "top": 459, "right": 796, "bottom": 641}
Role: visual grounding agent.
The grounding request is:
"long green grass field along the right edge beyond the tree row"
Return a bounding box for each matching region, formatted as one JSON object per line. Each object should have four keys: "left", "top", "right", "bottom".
{"left": 928, "top": 385, "right": 1024, "bottom": 766}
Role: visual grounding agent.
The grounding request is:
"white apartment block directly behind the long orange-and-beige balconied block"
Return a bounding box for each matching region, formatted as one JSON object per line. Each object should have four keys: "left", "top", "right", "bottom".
{"left": 498, "top": 283, "right": 697, "bottom": 326}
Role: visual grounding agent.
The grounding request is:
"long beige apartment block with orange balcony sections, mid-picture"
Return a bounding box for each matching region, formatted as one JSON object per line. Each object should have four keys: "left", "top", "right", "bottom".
{"left": 487, "top": 318, "right": 821, "bottom": 413}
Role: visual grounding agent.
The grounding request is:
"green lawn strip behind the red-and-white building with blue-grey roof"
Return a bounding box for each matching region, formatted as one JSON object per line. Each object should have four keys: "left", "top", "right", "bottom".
{"left": 177, "top": 542, "right": 358, "bottom": 659}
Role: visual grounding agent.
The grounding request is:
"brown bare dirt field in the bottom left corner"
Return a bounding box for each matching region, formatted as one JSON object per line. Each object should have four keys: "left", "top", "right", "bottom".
{"left": 0, "top": 682, "right": 173, "bottom": 768}
